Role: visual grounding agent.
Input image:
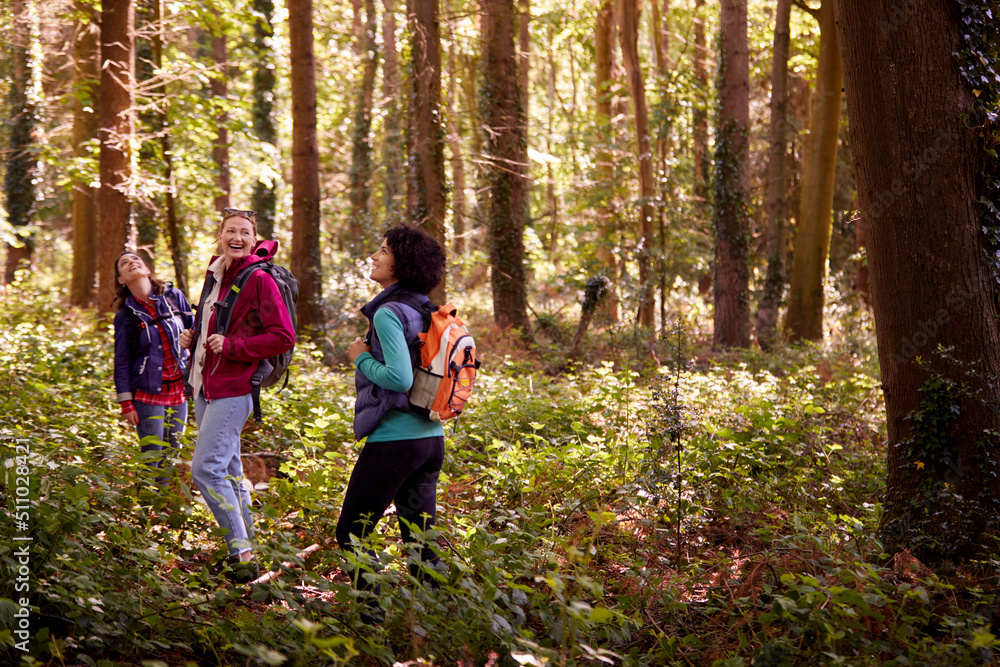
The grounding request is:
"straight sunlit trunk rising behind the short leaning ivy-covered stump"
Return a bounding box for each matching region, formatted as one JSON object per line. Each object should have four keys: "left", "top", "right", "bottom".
{"left": 594, "top": 0, "right": 621, "bottom": 322}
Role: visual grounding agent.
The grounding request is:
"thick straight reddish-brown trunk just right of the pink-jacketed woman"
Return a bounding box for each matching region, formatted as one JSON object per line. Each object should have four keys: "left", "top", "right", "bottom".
{"left": 287, "top": 0, "right": 325, "bottom": 337}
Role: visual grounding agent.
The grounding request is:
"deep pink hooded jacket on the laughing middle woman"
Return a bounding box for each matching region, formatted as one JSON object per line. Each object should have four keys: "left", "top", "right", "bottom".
{"left": 192, "top": 241, "right": 295, "bottom": 400}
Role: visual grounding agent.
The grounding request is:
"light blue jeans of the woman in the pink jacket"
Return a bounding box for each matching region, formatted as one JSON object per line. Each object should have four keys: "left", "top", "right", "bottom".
{"left": 191, "top": 393, "right": 253, "bottom": 556}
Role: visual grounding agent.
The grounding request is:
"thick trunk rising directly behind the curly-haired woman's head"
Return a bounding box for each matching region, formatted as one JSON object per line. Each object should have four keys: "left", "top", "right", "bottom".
{"left": 406, "top": 0, "right": 447, "bottom": 303}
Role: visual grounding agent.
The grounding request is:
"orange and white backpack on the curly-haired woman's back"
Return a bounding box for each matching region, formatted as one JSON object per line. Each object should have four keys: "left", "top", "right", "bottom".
{"left": 409, "top": 303, "right": 480, "bottom": 421}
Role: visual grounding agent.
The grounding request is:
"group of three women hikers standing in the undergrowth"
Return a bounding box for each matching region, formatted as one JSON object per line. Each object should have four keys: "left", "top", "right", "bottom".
{"left": 114, "top": 209, "right": 444, "bottom": 608}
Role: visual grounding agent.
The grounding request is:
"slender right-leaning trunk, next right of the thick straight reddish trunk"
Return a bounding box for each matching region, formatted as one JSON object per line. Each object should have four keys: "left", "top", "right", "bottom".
{"left": 350, "top": 0, "right": 378, "bottom": 256}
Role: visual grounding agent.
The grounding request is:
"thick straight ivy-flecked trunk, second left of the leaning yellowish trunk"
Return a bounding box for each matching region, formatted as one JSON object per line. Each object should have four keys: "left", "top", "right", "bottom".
{"left": 712, "top": 0, "right": 750, "bottom": 347}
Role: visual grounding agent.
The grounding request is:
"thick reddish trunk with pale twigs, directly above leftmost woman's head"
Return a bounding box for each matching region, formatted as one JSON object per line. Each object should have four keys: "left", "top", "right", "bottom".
{"left": 97, "top": 0, "right": 135, "bottom": 312}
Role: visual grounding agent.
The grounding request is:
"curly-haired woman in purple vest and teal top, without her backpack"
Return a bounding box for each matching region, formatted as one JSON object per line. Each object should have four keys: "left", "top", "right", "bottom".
{"left": 337, "top": 226, "right": 444, "bottom": 623}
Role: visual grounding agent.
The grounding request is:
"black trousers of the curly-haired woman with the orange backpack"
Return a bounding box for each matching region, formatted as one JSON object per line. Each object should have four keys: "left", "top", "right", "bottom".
{"left": 337, "top": 436, "right": 444, "bottom": 595}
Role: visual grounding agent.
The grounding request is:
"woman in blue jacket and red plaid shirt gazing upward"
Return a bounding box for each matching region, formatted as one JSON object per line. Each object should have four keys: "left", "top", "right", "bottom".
{"left": 114, "top": 252, "right": 194, "bottom": 482}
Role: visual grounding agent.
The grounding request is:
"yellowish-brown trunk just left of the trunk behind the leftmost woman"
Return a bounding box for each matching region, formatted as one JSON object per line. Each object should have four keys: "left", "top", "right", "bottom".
{"left": 70, "top": 0, "right": 100, "bottom": 307}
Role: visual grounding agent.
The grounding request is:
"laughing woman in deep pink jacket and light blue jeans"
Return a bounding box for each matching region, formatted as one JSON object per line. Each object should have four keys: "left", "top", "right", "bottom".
{"left": 181, "top": 209, "right": 295, "bottom": 583}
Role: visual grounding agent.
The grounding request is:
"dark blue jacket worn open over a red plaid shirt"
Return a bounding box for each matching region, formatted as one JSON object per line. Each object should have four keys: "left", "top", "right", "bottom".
{"left": 115, "top": 283, "right": 194, "bottom": 403}
